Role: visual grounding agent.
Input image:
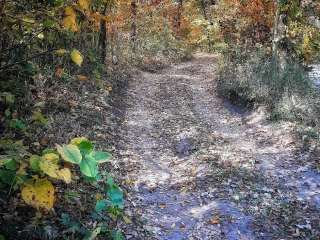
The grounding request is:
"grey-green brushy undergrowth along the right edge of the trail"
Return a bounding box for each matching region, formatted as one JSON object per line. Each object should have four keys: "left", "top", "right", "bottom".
{"left": 218, "top": 49, "right": 320, "bottom": 158}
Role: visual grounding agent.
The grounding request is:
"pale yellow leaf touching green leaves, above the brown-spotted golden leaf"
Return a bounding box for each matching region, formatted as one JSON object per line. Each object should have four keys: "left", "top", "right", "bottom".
{"left": 39, "top": 153, "right": 71, "bottom": 183}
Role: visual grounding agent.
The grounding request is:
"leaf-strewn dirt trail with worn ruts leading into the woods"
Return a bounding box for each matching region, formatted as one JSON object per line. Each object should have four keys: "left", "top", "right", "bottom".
{"left": 117, "top": 54, "right": 320, "bottom": 240}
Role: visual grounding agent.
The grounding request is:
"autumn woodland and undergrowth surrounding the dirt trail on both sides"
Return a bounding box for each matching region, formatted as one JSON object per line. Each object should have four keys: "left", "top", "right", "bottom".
{"left": 0, "top": 0, "right": 320, "bottom": 239}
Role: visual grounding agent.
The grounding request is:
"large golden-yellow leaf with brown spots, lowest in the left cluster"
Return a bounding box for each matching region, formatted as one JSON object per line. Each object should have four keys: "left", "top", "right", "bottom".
{"left": 21, "top": 179, "right": 54, "bottom": 210}
